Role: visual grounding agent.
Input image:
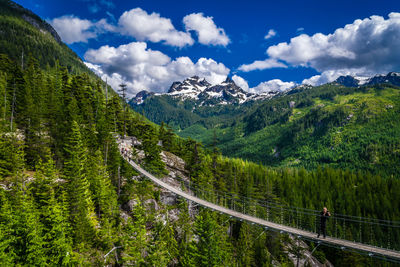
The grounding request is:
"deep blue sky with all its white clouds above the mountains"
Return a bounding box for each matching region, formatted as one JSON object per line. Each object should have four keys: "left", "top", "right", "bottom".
{"left": 16, "top": 0, "right": 400, "bottom": 94}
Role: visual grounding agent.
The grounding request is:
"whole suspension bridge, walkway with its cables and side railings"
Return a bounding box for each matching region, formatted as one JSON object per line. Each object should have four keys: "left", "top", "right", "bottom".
{"left": 117, "top": 140, "right": 400, "bottom": 263}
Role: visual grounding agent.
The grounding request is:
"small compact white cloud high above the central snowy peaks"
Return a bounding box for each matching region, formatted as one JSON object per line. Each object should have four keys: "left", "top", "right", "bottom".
{"left": 183, "top": 13, "right": 230, "bottom": 46}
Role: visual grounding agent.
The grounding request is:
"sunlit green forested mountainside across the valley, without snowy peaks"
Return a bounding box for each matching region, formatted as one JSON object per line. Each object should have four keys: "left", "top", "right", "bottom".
{"left": 178, "top": 84, "right": 400, "bottom": 177}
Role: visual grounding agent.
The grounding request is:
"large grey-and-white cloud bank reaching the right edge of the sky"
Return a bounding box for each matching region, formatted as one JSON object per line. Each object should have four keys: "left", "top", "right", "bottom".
{"left": 267, "top": 12, "right": 400, "bottom": 78}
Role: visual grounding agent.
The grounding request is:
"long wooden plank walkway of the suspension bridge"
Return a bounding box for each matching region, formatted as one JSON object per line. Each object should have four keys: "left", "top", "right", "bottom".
{"left": 121, "top": 155, "right": 400, "bottom": 261}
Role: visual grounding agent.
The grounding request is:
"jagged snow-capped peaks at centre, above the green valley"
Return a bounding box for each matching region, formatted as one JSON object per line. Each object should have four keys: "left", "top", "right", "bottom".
{"left": 131, "top": 76, "right": 280, "bottom": 106}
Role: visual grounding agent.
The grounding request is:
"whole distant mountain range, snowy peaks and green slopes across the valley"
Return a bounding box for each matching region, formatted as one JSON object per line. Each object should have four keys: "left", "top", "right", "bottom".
{"left": 127, "top": 72, "right": 400, "bottom": 178}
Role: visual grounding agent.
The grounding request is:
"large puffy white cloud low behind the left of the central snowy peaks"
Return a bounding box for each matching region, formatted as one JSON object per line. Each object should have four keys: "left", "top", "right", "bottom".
{"left": 84, "top": 42, "right": 230, "bottom": 97}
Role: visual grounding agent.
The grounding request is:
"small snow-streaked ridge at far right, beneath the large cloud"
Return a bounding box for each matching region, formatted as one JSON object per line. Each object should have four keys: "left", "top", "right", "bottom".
{"left": 334, "top": 72, "right": 400, "bottom": 87}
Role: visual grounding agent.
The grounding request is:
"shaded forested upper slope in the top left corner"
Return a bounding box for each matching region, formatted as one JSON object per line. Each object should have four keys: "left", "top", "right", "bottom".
{"left": 0, "top": 0, "right": 99, "bottom": 77}
